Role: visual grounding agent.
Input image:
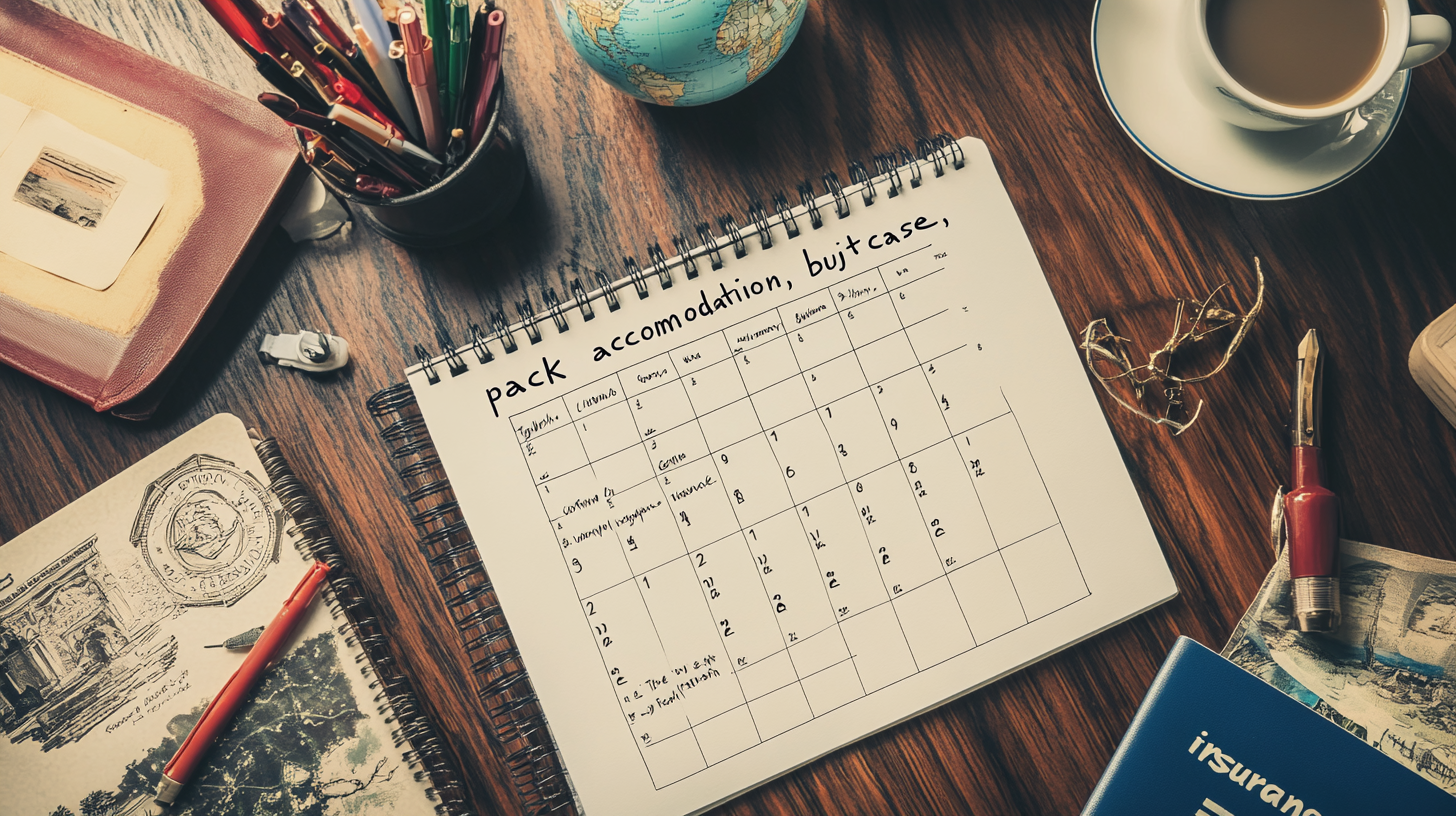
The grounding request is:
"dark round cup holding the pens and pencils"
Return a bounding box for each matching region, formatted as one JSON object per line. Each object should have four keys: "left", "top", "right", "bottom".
{"left": 297, "top": 82, "right": 526, "bottom": 248}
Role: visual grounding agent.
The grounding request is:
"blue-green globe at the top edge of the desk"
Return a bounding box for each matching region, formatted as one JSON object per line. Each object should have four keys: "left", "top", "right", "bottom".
{"left": 553, "top": 0, "right": 808, "bottom": 105}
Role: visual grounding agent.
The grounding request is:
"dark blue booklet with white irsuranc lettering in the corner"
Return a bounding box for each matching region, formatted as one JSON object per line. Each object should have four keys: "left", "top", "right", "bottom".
{"left": 1082, "top": 637, "right": 1456, "bottom": 816}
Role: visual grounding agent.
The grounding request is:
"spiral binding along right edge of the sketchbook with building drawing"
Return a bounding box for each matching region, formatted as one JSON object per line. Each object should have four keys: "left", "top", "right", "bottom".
{"left": 258, "top": 439, "right": 470, "bottom": 816}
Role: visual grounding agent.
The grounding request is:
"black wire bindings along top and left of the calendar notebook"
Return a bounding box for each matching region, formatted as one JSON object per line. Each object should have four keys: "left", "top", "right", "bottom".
{"left": 367, "top": 134, "right": 965, "bottom": 813}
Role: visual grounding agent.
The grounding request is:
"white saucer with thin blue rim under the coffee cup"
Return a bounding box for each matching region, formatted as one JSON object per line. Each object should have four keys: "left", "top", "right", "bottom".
{"left": 1092, "top": 0, "right": 1411, "bottom": 198}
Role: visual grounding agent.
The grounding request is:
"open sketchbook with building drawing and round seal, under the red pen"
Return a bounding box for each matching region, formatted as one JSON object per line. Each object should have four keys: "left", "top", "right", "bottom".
{"left": 0, "top": 414, "right": 463, "bottom": 816}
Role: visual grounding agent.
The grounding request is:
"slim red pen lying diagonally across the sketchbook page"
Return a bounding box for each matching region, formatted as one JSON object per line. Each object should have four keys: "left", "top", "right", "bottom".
{"left": 156, "top": 561, "right": 329, "bottom": 804}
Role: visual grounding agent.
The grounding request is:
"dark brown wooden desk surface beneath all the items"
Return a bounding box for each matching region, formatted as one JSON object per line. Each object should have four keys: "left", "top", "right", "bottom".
{"left": 8, "top": 0, "right": 1456, "bottom": 815}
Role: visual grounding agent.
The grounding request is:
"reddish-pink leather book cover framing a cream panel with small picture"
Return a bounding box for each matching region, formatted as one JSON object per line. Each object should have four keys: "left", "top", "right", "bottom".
{"left": 0, "top": 0, "right": 303, "bottom": 420}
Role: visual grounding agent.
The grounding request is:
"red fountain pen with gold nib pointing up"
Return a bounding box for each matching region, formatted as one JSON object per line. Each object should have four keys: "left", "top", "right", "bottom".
{"left": 1284, "top": 329, "right": 1340, "bottom": 632}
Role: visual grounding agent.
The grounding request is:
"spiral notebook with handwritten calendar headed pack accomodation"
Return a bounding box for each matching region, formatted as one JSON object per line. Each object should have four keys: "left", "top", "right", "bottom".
{"left": 370, "top": 137, "right": 1175, "bottom": 816}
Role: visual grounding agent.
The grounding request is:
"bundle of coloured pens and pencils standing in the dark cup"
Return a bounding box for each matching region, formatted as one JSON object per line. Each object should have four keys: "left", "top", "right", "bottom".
{"left": 201, "top": 0, "right": 505, "bottom": 198}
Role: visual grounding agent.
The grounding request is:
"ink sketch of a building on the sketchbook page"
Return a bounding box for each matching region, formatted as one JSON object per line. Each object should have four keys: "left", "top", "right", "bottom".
{"left": 0, "top": 536, "right": 176, "bottom": 750}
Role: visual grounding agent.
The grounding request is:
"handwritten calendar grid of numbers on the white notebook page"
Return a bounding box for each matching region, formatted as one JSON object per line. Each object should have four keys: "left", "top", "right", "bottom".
{"left": 511, "top": 245, "right": 1089, "bottom": 790}
